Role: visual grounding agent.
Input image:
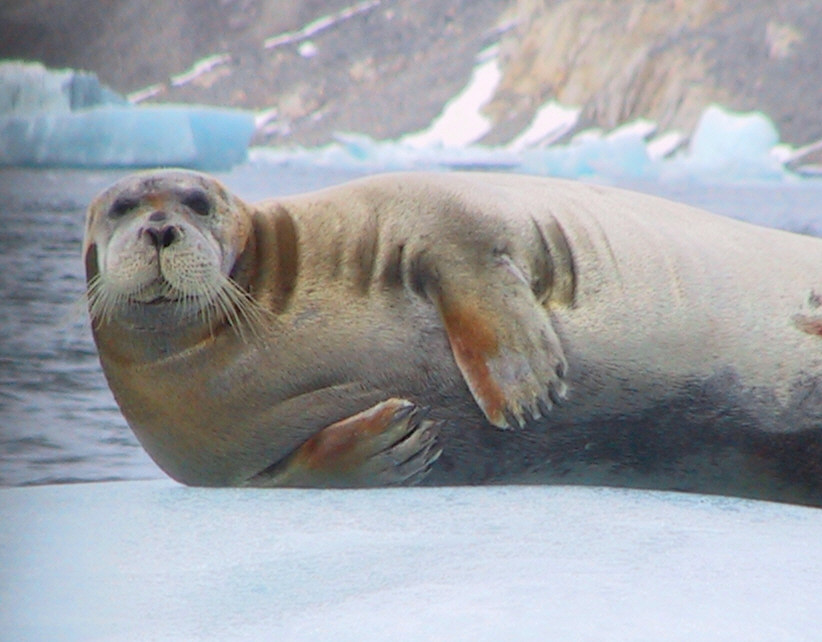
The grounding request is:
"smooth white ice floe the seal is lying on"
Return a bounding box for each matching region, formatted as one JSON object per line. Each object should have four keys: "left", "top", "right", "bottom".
{"left": 0, "top": 481, "right": 822, "bottom": 641}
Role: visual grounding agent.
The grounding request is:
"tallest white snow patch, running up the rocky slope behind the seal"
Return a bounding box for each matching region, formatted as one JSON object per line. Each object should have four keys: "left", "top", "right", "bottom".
{"left": 400, "top": 45, "right": 502, "bottom": 148}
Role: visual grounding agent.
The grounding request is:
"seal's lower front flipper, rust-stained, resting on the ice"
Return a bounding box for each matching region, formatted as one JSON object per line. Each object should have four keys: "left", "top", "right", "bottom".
{"left": 247, "top": 399, "right": 442, "bottom": 488}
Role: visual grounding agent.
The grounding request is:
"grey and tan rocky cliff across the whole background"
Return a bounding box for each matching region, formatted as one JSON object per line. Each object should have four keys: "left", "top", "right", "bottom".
{"left": 0, "top": 0, "right": 822, "bottom": 145}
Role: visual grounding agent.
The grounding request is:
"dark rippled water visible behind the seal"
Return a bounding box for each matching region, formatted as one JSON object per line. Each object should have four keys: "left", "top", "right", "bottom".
{"left": 0, "top": 166, "right": 822, "bottom": 486}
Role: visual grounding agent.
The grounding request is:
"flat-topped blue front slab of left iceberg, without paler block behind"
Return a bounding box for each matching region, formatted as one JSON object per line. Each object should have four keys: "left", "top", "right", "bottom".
{"left": 0, "top": 105, "right": 255, "bottom": 170}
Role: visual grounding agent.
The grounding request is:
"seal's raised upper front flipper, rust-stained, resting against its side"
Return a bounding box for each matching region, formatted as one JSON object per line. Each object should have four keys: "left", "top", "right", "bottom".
{"left": 429, "top": 254, "right": 567, "bottom": 428}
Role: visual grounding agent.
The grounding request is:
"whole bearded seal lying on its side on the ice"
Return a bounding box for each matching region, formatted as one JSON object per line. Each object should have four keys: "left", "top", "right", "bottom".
{"left": 84, "top": 170, "right": 822, "bottom": 505}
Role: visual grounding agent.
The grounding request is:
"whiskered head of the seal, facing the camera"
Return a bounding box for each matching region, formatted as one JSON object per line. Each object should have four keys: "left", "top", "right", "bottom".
{"left": 84, "top": 171, "right": 258, "bottom": 336}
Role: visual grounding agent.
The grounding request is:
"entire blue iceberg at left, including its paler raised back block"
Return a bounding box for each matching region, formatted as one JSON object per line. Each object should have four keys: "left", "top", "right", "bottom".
{"left": 0, "top": 61, "right": 256, "bottom": 170}
